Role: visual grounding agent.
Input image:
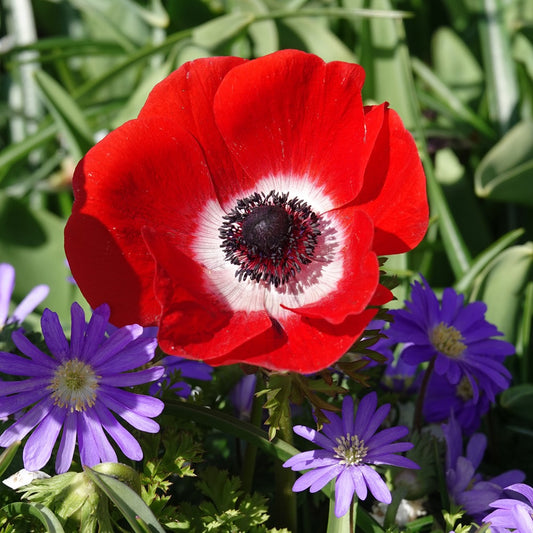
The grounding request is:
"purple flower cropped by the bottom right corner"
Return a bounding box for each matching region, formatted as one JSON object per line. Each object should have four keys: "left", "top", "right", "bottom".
{"left": 483, "top": 483, "right": 533, "bottom": 533}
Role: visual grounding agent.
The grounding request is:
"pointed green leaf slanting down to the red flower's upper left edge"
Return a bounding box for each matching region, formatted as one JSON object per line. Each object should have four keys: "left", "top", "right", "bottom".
{"left": 35, "top": 70, "right": 94, "bottom": 160}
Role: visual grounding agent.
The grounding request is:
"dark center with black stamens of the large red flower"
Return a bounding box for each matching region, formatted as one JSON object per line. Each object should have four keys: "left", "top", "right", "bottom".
{"left": 219, "top": 191, "right": 320, "bottom": 287}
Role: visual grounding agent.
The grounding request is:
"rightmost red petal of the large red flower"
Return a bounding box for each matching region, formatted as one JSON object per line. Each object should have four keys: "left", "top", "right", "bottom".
{"left": 355, "top": 104, "right": 429, "bottom": 255}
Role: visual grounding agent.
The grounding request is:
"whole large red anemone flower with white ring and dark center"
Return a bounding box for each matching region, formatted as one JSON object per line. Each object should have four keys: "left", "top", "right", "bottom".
{"left": 65, "top": 50, "right": 428, "bottom": 373}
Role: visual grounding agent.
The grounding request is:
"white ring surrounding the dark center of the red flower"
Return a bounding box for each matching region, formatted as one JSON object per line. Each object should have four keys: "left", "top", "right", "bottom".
{"left": 191, "top": 176, "right": 347, "bottom": 319}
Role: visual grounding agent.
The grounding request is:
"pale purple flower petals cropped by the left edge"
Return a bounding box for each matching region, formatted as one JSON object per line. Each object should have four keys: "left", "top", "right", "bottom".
{"left": 0, "top": 263, "right": 49, "bottom": 329}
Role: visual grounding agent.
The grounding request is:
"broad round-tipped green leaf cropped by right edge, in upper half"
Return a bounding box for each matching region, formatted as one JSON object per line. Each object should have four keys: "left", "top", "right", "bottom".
{"left": 474, "top": 120, "right": 533, "bottom": 206}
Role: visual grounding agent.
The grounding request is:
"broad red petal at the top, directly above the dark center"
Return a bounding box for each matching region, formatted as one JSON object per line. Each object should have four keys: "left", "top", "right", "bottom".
{"left": 214, "top": 50, "right": 366, "bottom": 207}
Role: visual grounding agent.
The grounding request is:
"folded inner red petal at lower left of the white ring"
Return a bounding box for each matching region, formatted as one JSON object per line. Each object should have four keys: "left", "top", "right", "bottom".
{"left": 143, "top": 228, "right": 272, "bottom": 361}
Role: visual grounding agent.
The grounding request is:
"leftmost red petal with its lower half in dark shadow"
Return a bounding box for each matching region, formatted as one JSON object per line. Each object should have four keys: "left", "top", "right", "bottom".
{"left": 65, "top": 118, "right": 215, "bottom": 326}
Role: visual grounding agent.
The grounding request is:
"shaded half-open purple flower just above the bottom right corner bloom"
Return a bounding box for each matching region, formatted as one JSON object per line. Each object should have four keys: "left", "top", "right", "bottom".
{"left": 442, "top": 415, "right": 526, "bottom": 520}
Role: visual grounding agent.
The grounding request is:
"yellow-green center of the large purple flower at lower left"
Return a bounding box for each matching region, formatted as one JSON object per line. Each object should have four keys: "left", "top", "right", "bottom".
{"left": 48, "top": 359, "right": 99, "bottom": 413}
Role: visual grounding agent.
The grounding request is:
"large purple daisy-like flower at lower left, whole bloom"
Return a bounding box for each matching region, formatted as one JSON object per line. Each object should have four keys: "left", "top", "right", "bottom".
{"left": 0, "top": 303, "right": 164, "bottom": 473}
